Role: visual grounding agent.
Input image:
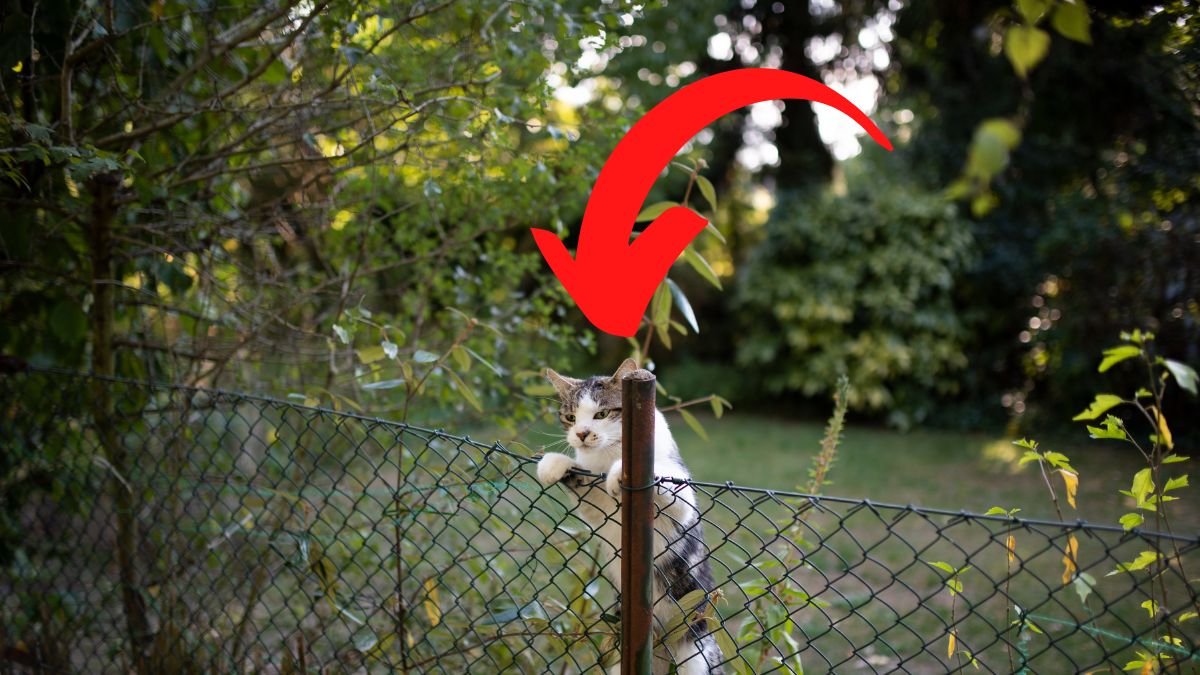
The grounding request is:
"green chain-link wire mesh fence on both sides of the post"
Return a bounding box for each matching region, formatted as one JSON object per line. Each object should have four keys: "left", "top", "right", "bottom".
{"left": 0, "top": 371, "right": 1200, "bottom": 674}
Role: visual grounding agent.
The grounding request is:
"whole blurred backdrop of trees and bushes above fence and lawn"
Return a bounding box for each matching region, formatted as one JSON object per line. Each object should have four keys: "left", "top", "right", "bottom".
{"left": 0, "top": 0, "right": 1200, "bottom": 437}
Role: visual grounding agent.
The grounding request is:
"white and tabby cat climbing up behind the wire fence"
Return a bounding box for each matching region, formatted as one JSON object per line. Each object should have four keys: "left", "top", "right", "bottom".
{"left": 538, "top": 359, "right": 725, "bottom": 675}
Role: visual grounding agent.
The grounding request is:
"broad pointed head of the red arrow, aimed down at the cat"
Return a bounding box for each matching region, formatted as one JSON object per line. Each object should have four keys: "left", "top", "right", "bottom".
{"left": 532, "top": 201, "right": 708, "bottom": 338}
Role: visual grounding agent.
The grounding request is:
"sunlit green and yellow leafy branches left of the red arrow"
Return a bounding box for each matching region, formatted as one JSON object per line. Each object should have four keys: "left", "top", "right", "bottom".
{"left": 0, "top": 0, "right": 667, "bottom": 425}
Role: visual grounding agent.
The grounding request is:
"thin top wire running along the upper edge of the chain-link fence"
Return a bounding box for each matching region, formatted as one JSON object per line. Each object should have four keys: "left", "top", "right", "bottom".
{"left": 17, "top": 365, "right": 1200, "bottom": 546}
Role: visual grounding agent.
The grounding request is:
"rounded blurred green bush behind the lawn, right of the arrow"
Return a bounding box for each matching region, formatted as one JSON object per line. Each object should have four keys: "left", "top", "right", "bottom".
{"left": 737, "top": 176, "right": 972, "bottom": 425}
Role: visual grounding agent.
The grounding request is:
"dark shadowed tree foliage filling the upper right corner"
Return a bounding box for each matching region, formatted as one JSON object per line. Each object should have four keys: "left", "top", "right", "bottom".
{"left": 884, "top": 0, "right": 1200, "bottom": 429}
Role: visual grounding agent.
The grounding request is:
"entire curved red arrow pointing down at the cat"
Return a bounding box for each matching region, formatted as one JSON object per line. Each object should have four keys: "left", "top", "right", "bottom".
{"left": 533, "top": 68, "right": 892, "bottom": 336}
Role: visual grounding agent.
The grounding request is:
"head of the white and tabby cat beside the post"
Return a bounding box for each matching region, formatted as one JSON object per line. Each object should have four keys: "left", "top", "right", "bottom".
{"left": 546, "top": 359, "right": 637, "bottom": 450}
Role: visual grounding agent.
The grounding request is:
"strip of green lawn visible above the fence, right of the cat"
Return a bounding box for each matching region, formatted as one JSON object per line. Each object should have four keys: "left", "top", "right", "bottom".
{"left": 667, "top": 413, "right": 1200, "bottom": 533}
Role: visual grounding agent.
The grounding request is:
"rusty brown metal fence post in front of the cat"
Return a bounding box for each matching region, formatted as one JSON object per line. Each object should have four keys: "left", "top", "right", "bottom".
{"left": 620, "top": 369, "right": 655, "bottom": 675}
